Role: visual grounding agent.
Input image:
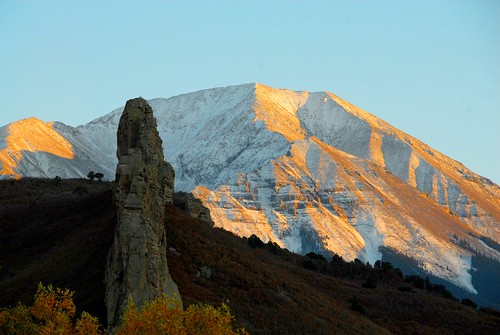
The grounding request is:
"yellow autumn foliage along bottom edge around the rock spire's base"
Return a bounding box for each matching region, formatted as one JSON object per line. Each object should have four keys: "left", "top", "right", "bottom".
{"left": 0, "top": 284, "right": 248, "bottom": 335}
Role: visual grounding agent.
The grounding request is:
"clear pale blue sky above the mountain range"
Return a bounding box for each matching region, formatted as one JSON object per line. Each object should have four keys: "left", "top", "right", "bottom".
{"left": 0, "top": 0, "right": 500, "bottom": 183}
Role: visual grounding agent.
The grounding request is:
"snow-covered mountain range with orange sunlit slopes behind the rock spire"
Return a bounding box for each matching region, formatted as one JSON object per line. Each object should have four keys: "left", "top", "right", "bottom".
{"left": 0, "top": 84, "right": 500, "bottom": 305}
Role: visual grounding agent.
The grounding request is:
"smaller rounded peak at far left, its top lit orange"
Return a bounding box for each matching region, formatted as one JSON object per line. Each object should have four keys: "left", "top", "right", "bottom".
{"left": 0, "top": 117, "right": 114, "bottom": 179}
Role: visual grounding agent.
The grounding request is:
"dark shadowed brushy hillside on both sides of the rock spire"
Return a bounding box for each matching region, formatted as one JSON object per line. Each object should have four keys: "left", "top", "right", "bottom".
{"left": 0, "top": 178, "right": 500, "bottom": 334}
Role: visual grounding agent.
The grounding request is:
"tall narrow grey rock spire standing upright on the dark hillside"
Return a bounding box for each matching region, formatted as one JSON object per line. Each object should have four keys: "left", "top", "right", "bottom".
{"left": 106, "top": 98, "right": 180, "bottom": 327}
